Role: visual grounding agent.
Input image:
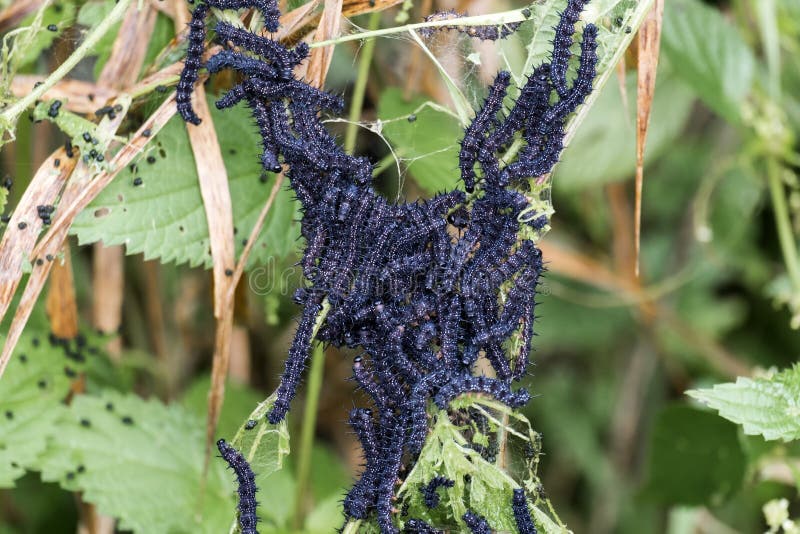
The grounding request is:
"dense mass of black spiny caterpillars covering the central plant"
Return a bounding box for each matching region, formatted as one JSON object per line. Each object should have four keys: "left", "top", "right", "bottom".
{"left": 177, "top": 0, "right": 597, "bottom": 533}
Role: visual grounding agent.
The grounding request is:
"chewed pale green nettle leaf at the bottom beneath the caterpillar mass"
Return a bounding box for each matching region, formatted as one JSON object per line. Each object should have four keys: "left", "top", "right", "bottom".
{"left": 398, "top": 402, "right": 567, "bottom": 533}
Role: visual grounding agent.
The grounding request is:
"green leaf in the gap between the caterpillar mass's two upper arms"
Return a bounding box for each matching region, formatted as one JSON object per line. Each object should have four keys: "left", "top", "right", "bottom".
{"left": 378, "top": 87, "right": 464, "bottom": 194}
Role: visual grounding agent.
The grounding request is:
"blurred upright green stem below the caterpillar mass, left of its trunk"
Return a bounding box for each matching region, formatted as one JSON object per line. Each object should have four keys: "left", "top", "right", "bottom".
{"left": 293, "top": 342, "right": 325, "bottom": 529}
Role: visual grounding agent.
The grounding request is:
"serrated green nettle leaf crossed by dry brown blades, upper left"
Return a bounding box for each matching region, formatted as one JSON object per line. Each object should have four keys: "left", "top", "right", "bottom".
{"left": 72, "top": 97, "right": 299, "bottom": 268}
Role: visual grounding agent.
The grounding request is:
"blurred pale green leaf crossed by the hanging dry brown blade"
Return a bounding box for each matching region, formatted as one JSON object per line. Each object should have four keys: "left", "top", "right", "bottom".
{"left": 555, "top": 69, "right": 694, "bottom": 192}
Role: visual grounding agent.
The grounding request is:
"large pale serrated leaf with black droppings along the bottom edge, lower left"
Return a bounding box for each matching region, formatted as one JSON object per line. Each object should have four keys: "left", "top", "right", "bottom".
{"left": 39, "top": 392, "right": 236, "bottom": 534}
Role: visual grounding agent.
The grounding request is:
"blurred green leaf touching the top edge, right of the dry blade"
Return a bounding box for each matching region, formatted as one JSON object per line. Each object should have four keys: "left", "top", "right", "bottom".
{"left": 664, "top": 0, "right": 755, "bottom": 124}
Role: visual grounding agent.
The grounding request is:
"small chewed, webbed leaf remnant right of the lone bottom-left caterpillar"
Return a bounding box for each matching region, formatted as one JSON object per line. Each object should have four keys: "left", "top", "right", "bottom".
{"left": 223, "top": 393, "right": 294, "bottom": 533}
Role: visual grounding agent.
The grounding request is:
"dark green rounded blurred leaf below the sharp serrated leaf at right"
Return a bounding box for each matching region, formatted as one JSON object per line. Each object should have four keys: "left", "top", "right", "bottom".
{"left": 645, "top": 404, "right": 747, "bottom": 504}
